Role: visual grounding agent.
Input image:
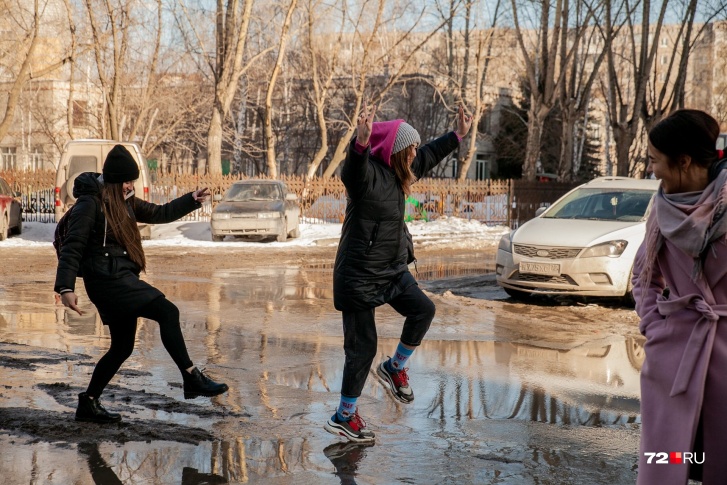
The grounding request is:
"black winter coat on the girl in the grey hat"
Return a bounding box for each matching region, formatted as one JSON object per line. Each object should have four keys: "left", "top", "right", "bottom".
{"left": 333, "top": 132, "right": 459, "bottom": 311}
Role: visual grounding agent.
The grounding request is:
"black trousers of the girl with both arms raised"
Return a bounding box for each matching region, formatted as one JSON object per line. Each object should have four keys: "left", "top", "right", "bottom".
{"left": 341, "top": 285, "right": 435, "bottom": 397}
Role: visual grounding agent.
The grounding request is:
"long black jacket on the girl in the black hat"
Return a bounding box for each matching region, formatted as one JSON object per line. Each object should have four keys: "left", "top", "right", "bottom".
{"left": 55, "top": 172, "right": 201, "bottom": 324}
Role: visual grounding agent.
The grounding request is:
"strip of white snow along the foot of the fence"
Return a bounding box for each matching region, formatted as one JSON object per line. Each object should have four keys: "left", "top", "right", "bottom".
{"left": 0, "top": 216, "right": 509, "bottom": 249}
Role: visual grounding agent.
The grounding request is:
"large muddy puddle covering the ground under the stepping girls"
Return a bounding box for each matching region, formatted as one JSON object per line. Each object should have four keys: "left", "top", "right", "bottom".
{"left": 0, "top": 257, "right": 644, "bottom": 484}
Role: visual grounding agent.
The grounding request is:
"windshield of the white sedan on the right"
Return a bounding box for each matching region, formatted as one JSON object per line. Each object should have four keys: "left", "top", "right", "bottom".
{"left": 543, "top": 187, "right": 655, "bottom": 222}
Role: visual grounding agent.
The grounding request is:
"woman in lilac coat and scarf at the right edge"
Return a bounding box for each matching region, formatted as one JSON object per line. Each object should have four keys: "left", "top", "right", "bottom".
{"left": 633, "top": 110, "right": 727, "bottom": 485}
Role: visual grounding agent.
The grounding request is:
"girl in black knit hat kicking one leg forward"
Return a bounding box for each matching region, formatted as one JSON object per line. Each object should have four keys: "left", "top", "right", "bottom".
{"left": 55, "top": 145, "right": 227, "bottom": 423}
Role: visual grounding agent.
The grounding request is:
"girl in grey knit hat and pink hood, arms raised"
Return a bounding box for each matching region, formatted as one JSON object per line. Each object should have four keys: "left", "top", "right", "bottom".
{"left": 324, "top": 105, "right": 472, "bottom": 443}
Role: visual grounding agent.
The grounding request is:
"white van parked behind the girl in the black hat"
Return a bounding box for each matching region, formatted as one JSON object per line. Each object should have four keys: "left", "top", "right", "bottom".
{"left": 55, "top": 140, "right": 151, "bottom": 239}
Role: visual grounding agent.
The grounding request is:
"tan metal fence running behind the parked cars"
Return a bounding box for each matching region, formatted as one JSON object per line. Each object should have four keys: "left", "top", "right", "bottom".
{"left": 0, "top": 171, "right": 574, "bottom": 227}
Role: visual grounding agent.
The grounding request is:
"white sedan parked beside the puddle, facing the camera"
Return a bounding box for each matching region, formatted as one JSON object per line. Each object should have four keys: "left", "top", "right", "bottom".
{"left": 496, "top": 177, "right": 659, "bottom": 299}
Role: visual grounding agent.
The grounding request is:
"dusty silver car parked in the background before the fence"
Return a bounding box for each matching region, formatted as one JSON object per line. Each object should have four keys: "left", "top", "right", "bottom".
{"left": 210, "top": 179, "right": 300, "bottom": 242}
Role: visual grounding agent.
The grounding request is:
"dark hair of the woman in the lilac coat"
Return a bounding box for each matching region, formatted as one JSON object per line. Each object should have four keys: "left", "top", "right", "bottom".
{"left": 649, "top": 109, "right": 719, "bottom": 168}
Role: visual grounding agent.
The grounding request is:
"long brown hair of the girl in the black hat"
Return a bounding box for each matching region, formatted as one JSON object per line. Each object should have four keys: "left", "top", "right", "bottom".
{"left": 101, "top": 183, "right": 146, "bottom": 270}
